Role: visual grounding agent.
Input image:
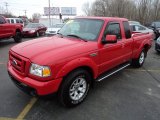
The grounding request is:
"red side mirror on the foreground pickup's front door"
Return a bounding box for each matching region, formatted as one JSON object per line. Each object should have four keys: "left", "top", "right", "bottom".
{"left": 102, "top": 35, "right": 117, "bottom": 44}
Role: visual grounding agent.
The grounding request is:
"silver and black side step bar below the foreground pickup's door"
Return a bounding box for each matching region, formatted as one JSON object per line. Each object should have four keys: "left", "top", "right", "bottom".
{"left": 95, "top": 63, "right": 130, "bottom": 82}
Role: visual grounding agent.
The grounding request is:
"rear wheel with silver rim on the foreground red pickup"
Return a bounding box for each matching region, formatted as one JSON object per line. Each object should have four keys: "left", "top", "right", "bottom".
{"left": 131, "top": 50, "right": 147, "bottom": 68}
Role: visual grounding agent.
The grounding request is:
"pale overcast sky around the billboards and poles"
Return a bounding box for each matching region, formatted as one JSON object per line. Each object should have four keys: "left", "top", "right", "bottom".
{"left": 0, "top": 0, "right": 94, "bottom": 17}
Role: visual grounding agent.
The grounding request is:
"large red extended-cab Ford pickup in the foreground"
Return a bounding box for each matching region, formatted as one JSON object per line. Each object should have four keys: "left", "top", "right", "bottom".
{"left": 8, "top": 17, "right": 152, "bottom": 107}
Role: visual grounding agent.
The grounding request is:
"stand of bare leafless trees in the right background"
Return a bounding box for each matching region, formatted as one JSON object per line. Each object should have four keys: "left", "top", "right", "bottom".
{"left": 82, "top": 0, "right": 160, "bottom": 24}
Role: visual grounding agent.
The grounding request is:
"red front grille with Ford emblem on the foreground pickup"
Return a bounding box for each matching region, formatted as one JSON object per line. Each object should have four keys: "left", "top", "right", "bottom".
{"left": 9, "top": 52, "right": 26, "bottom": 74}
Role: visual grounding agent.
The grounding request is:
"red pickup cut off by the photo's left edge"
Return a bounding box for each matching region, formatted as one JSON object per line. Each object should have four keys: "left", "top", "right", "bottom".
{"left": 0, "top": 16, "right": 22, "bottom": 43}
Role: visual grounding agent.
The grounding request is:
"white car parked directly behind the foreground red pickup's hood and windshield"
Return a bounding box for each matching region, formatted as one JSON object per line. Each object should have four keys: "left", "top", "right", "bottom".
{"left": 46, "top": 23, "right": 64, "bottom": 36}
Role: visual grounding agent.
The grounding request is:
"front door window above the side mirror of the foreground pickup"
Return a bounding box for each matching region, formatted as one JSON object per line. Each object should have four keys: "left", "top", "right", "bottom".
{"left": 104, "top": 23, "right": 122, "bottom": 39}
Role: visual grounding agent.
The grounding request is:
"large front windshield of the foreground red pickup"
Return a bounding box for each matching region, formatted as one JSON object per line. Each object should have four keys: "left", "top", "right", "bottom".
{"left": 59, "top": 18, "right": 103, "bottom": 41}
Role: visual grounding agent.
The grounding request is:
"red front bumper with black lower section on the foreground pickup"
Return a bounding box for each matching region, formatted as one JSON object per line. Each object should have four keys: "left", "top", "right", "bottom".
{"left": 8, "top": 64, "right": 62, "bottom": 96}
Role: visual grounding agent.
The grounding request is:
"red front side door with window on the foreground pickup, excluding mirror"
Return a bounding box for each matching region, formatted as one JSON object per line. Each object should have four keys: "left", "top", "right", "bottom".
{"left": 99, "top": 22, "right": 123, "bottom": 73}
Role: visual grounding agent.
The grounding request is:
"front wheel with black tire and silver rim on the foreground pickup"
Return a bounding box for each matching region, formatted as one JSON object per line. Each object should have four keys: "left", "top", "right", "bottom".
{"left": 58, "top": 69, "right": 92, "bottom": 107}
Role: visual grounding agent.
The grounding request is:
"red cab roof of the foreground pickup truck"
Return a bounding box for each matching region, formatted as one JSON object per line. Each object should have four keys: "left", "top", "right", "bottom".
{"left": 76, "top": 17, "right": 128, "bottom": 21}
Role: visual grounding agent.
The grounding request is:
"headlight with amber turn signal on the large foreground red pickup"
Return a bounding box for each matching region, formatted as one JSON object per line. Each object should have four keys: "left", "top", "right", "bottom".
{"left": 30, "top": 63, "right": 51, "bottom": 77}
